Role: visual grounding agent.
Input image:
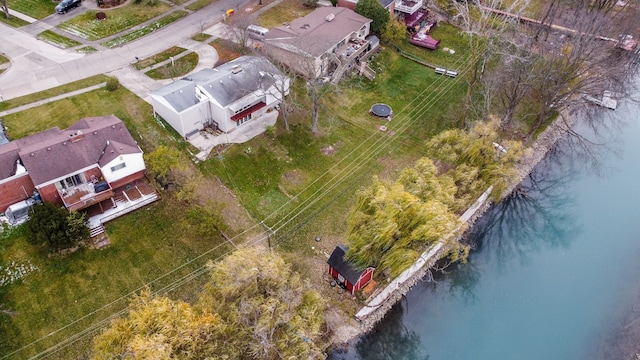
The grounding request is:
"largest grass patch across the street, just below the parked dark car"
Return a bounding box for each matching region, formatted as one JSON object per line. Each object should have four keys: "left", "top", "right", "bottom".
{"left": 58, "top": 2, "right": 171, "bottom": 40}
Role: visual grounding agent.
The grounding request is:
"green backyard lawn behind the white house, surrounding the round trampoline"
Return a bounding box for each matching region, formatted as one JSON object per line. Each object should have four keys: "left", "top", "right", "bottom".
{"left": 202, "top": 44, "right": 465, "bottom": 242}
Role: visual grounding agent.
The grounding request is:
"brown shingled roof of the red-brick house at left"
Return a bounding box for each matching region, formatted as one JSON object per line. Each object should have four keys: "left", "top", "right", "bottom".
{"left": 0, "top": 115, "right": 141, "bottom": 186}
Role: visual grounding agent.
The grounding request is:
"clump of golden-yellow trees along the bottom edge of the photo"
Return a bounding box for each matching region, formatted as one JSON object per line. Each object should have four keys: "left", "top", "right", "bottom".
{"left": 94, "top": 249, "right": 325, "bottom": 359}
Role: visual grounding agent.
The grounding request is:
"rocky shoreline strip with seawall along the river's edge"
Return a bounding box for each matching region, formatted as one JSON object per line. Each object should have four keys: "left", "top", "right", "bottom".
{"left": 329, "top": 116, "right": 573, "bottom": 349}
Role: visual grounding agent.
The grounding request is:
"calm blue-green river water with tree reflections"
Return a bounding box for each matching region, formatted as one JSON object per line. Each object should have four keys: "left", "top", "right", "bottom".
{"left": 330, "top": 97, "right": 640, "bottom": 360}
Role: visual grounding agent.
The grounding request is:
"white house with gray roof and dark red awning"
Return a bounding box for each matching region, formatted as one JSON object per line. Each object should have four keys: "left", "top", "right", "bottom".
{"left": 151, "top": 56, "right": 290, "bottom": 138}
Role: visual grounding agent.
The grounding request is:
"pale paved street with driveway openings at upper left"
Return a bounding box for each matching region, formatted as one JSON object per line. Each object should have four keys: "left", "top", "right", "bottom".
{"left": 0, "top": 0, "right": 248, "bottom": 99}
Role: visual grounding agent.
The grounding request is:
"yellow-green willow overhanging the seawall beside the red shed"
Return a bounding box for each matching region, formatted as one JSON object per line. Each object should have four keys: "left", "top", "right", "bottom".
{"left": 346, "top": 159, "right": 460, "bottom": 277}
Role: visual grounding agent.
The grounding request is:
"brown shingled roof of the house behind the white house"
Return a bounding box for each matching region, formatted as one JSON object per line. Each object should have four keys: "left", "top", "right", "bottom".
{"left": 264, "top": 6, "right": 371, "bottom": 57}
